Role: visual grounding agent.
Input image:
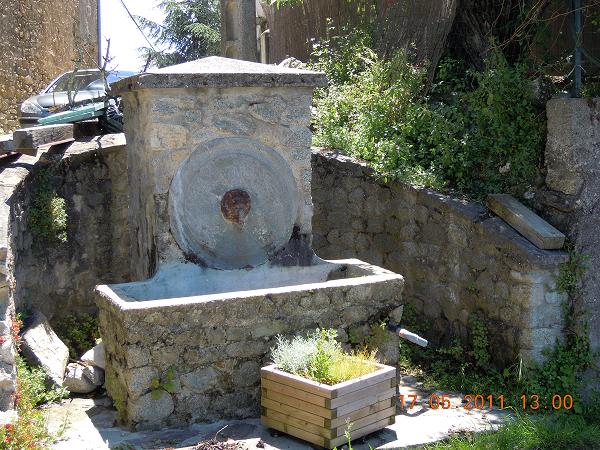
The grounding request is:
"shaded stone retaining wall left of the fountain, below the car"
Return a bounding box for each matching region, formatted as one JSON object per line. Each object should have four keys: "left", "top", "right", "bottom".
{"left": 0, "top": 135, "right": 129, "bottom": 320}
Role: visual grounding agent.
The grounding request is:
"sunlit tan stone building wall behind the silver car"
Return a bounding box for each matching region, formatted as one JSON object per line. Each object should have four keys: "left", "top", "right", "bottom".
{"left": 0, "top": 0, "right": 98, "bottom": 134}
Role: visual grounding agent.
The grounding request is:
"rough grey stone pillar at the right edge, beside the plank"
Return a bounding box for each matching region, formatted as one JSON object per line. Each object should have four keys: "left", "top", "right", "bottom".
{"left": 536, "top": 98, "right": 600, "bottom": 356}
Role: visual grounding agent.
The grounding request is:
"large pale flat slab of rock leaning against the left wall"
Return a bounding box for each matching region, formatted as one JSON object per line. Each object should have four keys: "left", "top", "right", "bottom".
{"left": 21, "top": 312, "right": 69, "bottom": 386}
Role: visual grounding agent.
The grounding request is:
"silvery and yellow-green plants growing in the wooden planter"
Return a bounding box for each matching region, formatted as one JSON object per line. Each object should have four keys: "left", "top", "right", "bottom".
{"left": 271, "top": 329, "right": 378, "bottom": 384}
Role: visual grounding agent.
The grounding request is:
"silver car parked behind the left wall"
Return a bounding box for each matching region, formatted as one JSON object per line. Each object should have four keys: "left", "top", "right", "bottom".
{"left": 19, "top": 69, "right": 135, "bottom": 128}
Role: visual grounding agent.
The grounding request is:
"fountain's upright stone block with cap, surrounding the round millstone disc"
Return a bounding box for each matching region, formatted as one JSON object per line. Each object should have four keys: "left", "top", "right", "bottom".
{"left": 115, "top": 58, "right": 324, "bottom": 280}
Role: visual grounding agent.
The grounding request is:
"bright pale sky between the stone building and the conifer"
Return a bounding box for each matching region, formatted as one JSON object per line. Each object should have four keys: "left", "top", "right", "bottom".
{"left": 100, "top": 0, "right": 164, "bottom": 71}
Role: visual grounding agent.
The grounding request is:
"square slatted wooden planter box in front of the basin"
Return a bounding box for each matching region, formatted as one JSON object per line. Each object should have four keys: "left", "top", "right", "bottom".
{"left": 260, "top": 364, "right": 396, "bottom": 448}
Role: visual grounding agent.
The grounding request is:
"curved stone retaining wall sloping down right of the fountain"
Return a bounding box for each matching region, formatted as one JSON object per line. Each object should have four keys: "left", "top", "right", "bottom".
{"left": 312, "top": 151, "right": 567, "bottom": 364}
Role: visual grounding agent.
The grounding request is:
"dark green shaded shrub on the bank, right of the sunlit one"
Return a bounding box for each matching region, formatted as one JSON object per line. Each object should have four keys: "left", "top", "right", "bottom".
{"left": 429, "top": 53, "right": 546, "bottom": 199}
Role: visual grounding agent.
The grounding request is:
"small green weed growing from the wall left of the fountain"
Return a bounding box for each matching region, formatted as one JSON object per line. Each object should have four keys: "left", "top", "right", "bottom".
{"left": 28, "top": 169, "right": 67, "bottom": 242}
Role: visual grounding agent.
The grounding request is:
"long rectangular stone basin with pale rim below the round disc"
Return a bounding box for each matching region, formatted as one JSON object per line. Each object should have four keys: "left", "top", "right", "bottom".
{"left": 96, "top": 257, "right": 404, "bottom": 429}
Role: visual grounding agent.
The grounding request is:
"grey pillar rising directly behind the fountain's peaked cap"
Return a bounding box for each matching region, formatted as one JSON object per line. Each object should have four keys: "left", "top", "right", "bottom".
{"left": 221, "top": 0, "right": 257, "bottom": 61}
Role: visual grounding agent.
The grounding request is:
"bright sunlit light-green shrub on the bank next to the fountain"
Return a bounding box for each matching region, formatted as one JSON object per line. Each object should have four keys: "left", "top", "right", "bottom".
{"left": 314, "top": 42, "right": 438, "bottom": 186}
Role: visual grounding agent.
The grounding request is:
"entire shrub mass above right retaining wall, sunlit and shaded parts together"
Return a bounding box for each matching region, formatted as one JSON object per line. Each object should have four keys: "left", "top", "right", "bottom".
{"left": 313, "top": 32, "right": 545, "bottom": 199}
